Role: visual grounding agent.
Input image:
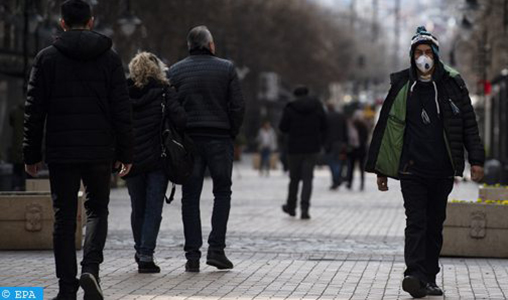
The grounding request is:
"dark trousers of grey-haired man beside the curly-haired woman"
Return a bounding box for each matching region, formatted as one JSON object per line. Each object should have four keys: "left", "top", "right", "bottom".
{"left": 182, "top": 137, "right": 233, "bottom": 260}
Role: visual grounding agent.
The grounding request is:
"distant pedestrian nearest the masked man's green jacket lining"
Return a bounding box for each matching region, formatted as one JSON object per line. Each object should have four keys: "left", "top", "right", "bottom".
{"left": 347, "top": 110, "right": 369, "bottom": 191}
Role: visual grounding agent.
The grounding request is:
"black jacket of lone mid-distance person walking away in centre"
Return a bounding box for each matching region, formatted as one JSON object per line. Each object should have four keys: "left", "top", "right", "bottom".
{"left": 279, "top": 96, "right": 327, "bottom": 154}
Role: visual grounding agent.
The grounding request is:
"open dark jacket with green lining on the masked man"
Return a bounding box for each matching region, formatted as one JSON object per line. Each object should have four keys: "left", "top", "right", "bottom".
{"left": 365, "top": 62, "right": 485, "bottom": 179}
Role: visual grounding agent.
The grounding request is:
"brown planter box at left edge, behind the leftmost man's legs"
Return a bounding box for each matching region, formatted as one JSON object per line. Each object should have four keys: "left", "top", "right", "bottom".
{"left": 0, "top": 192, "right": 83, "bottom": 250}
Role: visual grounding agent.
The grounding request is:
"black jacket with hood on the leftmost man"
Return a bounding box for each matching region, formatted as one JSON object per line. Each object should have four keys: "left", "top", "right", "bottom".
{"left": 23, "top": 30, "right": 133, "bottom": 164}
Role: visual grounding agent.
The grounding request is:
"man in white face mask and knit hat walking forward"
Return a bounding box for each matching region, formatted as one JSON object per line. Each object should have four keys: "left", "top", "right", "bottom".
{"left": 366, "top": 26, "right": 485, "bottom": 298}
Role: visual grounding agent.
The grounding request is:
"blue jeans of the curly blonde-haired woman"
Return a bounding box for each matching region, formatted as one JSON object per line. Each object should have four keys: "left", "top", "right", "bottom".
{"left": 126, "top": 170, "right": 168, "bottom": 261}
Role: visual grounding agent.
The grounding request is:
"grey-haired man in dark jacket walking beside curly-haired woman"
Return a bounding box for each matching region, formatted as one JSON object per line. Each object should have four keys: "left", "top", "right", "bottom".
{"left": 169, "top": 26, "right": 245, "bottom": 272}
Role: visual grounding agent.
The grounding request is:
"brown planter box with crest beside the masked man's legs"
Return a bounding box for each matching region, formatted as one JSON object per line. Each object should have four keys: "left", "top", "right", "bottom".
{"left": 441, "top": 202, "right": 508, "bottom": 258}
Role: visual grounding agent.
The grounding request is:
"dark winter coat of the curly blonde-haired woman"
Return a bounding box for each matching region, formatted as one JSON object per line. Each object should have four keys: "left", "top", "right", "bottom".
{"left": 126, "top": 79, "right": 186, "bottom": 177}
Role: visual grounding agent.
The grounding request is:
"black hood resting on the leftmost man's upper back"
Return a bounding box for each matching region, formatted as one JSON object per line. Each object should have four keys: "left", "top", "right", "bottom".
{"left": 53, "top": 30, "right": 113, "bottom": 61}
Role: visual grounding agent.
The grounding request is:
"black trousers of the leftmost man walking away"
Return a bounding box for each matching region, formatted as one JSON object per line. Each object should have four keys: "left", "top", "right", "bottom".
{"left": 49, "top": 163, "right": 111, "bottom": 290}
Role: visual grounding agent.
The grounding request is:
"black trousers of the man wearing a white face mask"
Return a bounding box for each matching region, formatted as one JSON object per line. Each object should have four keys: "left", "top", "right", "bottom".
{"left": 400, "top": 175, "right": 453, "bottom": 283}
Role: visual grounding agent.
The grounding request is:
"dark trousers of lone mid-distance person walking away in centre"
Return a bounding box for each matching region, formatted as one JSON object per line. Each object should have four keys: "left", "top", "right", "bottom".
{"left": 287, "top": 154, "right": 317, "bottom": 211}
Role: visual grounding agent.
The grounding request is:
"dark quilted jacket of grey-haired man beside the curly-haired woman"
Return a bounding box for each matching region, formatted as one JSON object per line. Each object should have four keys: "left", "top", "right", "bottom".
{"left": 169, "top": 49, "right": 245, "bottom": 137}
